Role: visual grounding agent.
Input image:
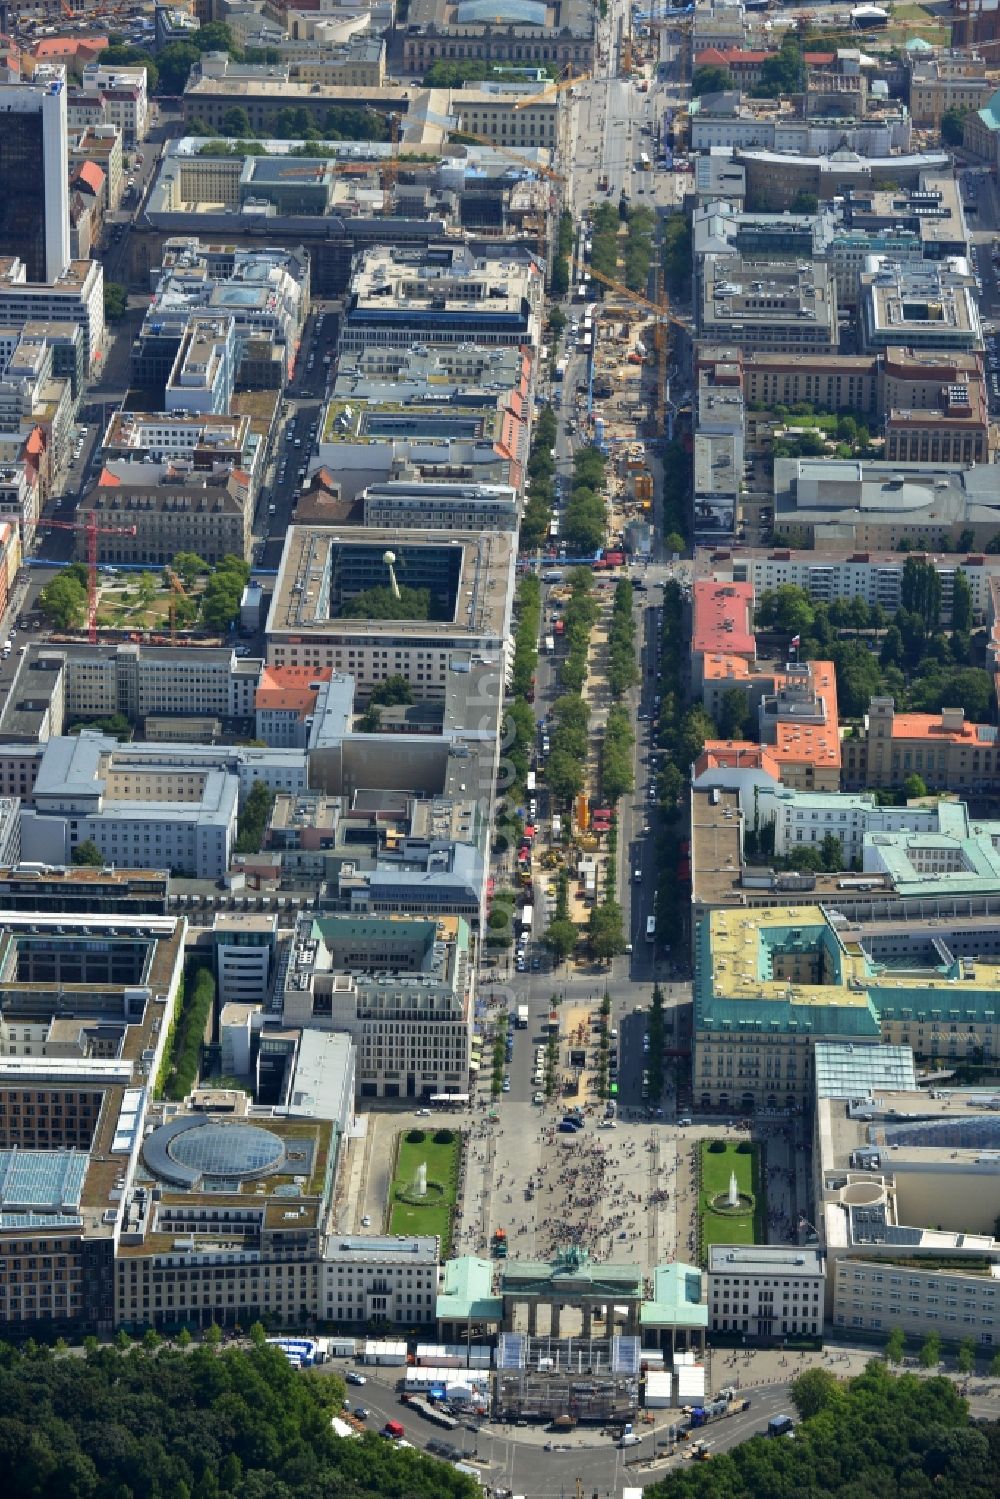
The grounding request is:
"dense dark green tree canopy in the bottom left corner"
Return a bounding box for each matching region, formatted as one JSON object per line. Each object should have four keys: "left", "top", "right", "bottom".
{"left": 0, "top": 1346, "right": 478, "bottom": 1499}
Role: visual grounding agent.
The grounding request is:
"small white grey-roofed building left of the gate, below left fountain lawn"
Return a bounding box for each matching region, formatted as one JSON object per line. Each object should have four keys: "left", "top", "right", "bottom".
{"left": 319, "top": 1234, "right": 439, "bottom": 1327}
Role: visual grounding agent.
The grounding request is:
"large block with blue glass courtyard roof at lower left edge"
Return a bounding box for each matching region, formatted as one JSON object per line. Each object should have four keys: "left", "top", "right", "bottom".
{"left": 0, "top": 911, "right": 184, "bottom": 1337}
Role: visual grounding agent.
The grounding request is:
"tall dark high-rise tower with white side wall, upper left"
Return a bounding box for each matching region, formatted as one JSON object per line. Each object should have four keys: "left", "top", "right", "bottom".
{"left": 0, "top": 66, "right": 69, "bottom": 282}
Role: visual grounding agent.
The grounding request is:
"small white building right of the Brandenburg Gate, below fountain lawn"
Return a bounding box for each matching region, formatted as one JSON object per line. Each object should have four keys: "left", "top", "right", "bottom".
{"left": 708, "top": 1244, "right": 826, "bottom": 1342}
